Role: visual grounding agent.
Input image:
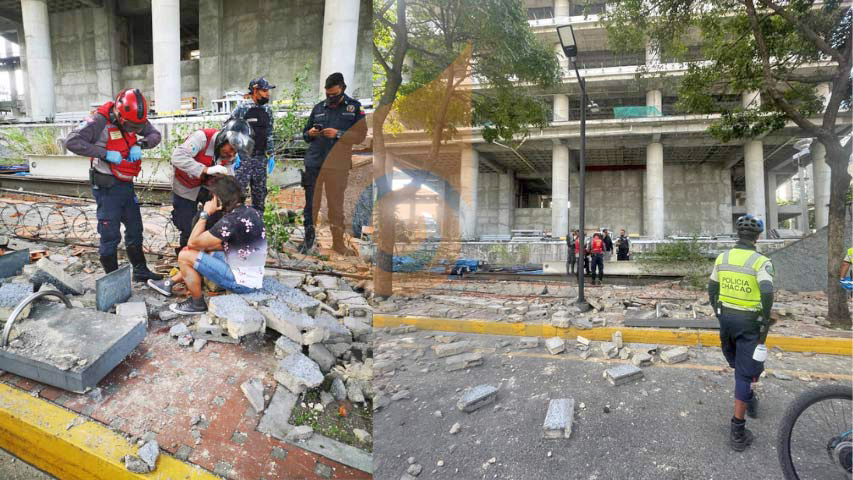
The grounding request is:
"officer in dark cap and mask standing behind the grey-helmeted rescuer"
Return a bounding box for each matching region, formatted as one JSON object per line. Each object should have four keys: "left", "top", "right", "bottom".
{"left": 231, "top": 77, "right": 275, "bottom": 213}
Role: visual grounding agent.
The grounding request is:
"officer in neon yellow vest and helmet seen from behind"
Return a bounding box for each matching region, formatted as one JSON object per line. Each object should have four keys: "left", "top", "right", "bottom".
{"left": 708, "top": 215, "right": 774, "bottom": 452}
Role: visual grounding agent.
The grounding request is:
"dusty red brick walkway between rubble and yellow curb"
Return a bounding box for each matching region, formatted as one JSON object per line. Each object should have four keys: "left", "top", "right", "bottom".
{"left": 0, "top": 322, "right": 371, "bottom": 480}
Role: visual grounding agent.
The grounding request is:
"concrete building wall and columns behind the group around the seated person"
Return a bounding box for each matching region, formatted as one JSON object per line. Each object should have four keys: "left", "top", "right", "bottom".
{"left": 0, "top": 0, "right": 372, "bottom": 122}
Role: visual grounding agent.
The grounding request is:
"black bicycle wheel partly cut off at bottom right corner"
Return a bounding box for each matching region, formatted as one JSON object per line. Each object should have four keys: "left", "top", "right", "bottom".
{"left": 776, "top": 385, "right": 853, "bottom": 480}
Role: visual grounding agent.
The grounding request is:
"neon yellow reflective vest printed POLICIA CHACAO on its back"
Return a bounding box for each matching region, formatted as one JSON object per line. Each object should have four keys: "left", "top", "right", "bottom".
{"left": 715, "top": 248, "right": 770, "bottom": 311}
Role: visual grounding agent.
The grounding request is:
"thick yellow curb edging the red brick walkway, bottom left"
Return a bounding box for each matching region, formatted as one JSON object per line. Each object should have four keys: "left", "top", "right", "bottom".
{"left": 0, "top": 384, "right": 219, "bottom": 480}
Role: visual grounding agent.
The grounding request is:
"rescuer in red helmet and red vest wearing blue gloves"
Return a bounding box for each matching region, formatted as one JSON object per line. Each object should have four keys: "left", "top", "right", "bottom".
{"left": 65, "top": 88, "right": 163, "bottom": 282}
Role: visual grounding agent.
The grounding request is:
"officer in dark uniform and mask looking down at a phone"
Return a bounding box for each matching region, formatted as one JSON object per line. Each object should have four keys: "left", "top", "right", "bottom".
{"left": 299, "top": 73, "right": 367, "bottom": 255}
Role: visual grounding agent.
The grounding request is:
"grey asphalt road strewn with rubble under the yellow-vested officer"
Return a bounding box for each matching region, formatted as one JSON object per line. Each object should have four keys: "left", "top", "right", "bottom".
{"left": 374, "top": 332, "right": 851, "bottom": 480}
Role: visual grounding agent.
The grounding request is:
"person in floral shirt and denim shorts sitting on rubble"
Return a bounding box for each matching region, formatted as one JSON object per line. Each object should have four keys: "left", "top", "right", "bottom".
{"left": 148, "top": 176, "right": 267, "bottom": 315}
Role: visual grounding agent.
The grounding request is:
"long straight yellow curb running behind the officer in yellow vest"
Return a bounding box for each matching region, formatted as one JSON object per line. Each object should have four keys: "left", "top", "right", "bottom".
{"left": 373, "top": 314, "right": 853, "bottom": 355}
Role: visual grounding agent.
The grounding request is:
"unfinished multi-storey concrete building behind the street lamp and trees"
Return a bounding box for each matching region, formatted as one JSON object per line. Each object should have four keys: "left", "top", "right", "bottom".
{"left": 388, "top": 0, "right": 850, "bottom": 244}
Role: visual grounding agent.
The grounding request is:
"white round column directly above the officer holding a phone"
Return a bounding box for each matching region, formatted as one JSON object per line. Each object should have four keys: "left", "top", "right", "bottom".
{"left": 320, "top": 0, "right": 361, "bottom": 96}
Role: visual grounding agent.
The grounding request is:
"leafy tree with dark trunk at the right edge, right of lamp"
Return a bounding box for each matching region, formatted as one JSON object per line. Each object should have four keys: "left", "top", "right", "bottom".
{"left": 605, "top": 0, "right": 853, "bottom": 328}
